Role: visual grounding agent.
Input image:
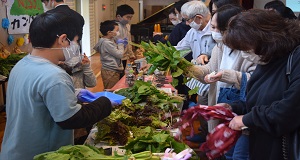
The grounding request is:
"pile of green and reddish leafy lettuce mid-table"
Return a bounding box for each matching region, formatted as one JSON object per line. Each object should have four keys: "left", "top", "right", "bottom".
{"left": 95, "top": 81, "right": 183, "bottom": 145}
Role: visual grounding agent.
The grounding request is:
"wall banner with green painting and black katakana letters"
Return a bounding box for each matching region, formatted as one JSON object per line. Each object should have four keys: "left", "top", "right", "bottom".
{"left": 6, "top": 0, "right": 44, "bottom": 34}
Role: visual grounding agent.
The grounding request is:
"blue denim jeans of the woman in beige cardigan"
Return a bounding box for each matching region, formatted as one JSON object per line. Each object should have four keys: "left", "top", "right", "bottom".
{"left": 225, "top": 134, "right": 249, "bottom": 160}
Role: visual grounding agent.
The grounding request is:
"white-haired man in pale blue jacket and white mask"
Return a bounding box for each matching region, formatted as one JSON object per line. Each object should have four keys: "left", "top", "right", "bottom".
{"left": 176, "top": 1, "right": 216, "bottom": 105}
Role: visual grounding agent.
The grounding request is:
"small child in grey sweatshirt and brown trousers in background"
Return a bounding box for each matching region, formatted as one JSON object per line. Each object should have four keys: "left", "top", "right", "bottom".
{"left": 94, "top": 21, "right": 127, "bottom": 89}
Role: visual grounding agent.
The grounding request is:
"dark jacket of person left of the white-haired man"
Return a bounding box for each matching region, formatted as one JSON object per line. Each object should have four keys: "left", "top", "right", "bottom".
{"left": 153, "top": 22, "right": 191, "bottom": 46}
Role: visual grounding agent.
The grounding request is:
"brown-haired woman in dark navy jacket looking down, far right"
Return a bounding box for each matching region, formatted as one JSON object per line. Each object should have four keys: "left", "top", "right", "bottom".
{"left": 219, "top": 10, "right": 300, "bottom": 160}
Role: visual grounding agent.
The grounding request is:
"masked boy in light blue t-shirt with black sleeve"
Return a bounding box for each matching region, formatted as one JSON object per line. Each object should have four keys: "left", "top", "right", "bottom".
{"left": 0, "top": 12, "right": 112, "bottom": 160}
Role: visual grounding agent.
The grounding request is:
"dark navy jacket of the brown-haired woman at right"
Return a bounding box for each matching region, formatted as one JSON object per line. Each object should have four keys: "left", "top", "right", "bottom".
{"left": 232, "top": 49, "right": 300, "bottom": 160}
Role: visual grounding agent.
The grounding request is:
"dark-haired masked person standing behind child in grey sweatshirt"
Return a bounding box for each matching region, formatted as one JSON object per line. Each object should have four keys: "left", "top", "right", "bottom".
{"left": 115, "top": 4, "right": 135, "bottom": 78}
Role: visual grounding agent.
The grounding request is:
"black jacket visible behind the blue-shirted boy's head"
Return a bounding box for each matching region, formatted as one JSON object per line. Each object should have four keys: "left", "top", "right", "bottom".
{"left": 48, "top": 4, "right": 84, "bottom": 41}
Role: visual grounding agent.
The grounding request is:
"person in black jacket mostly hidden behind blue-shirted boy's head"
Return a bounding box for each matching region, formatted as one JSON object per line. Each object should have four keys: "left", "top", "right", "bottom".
{"left": 48, "top": 0, "right": 84, "bottom": 42}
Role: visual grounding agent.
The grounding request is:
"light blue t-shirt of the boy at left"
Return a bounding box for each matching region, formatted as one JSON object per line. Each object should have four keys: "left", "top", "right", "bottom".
{"left": 0, "top": 55, "right": 81, "bottom": 160}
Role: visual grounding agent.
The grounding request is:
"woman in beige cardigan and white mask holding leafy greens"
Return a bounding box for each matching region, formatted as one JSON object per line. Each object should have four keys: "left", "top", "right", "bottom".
{"left": 184, "top": 5, "right": 256, "bottom": 160}
